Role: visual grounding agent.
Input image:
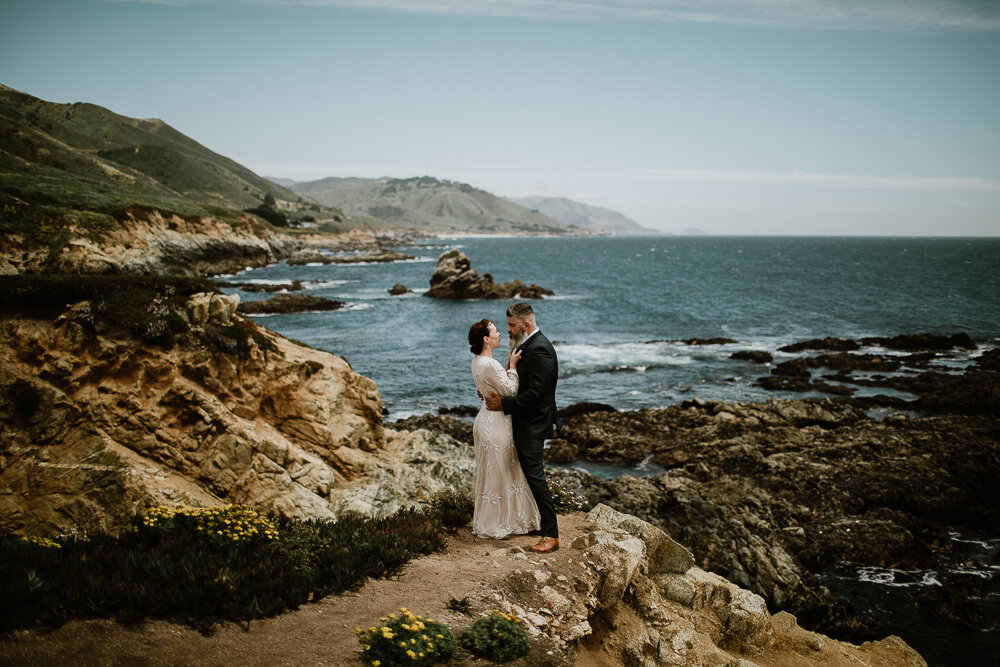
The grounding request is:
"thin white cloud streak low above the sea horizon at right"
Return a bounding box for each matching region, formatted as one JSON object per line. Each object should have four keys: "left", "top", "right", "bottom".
{"left": 627, "top": 169, "right": 1000, "bottom": 192}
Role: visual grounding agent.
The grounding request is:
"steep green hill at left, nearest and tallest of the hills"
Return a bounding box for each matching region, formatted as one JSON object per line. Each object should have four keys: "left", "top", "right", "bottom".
{"left": 0, "top": 85, "right": 340, "bottom": 222}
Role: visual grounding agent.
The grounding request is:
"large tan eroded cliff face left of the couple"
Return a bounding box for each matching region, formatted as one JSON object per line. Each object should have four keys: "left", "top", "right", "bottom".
{"left": 0, "top": 294, "right": 472, "bottom": 535}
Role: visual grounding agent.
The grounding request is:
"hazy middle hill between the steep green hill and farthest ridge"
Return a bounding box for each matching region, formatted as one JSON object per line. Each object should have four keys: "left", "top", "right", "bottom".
{"left": 291, "top": 176, "right": 588, "bottom": 235}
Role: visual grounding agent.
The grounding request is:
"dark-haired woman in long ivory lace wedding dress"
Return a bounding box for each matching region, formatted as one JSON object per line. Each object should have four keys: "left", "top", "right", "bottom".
{"left": 469, "top": 320, "right": 540, "bottom": 539}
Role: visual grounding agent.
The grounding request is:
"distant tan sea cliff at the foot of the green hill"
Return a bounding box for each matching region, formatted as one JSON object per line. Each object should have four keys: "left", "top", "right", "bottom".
{"left": 0, "top": 209, "right": 301, "bottom": 276}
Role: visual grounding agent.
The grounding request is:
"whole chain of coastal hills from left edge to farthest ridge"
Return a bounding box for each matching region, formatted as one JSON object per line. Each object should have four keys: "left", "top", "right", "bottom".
{"left": 0, "top": 85, "right": 654, "bottom": 235}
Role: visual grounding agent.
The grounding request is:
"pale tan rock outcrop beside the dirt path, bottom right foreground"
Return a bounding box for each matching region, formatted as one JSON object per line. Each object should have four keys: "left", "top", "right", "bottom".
{"left": 476, "top": 505, "right": 926, "bottom": 667}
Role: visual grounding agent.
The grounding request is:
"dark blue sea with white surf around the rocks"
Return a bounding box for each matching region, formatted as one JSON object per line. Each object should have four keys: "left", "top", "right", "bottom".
{"left": 221, "top": 236, "right": 1000, "bottom": 665}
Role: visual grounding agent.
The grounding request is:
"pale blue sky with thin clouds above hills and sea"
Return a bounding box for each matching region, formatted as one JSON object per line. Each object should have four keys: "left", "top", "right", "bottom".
{"left": 0, "top": 0, "right": 1000, "bottom": 236}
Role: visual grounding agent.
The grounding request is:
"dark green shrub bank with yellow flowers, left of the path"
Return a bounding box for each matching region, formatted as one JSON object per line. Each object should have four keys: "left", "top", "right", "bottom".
{"left": 0, "top": 505, "right": 444, "bottom": 632}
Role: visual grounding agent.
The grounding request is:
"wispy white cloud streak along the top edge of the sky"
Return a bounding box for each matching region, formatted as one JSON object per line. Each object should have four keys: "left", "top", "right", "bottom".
{"left": 217, "top": 0, "right": 1000, "bottom": 32}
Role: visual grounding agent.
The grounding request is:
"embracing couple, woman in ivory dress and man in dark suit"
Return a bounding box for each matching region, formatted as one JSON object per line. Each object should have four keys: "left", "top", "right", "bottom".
{"left": 469, "top": 303, "right": 560, "bottom": 553}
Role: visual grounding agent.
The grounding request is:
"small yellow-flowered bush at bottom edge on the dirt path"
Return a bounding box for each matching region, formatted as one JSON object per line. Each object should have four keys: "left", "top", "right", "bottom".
{"left": 354, "top": 607, "right": 458, "bottom": 667}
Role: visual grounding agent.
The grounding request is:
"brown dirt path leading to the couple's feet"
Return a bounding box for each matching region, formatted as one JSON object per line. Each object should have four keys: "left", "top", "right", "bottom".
{"left": 0, "top": 512, "right": 600, "bottom": 667}
